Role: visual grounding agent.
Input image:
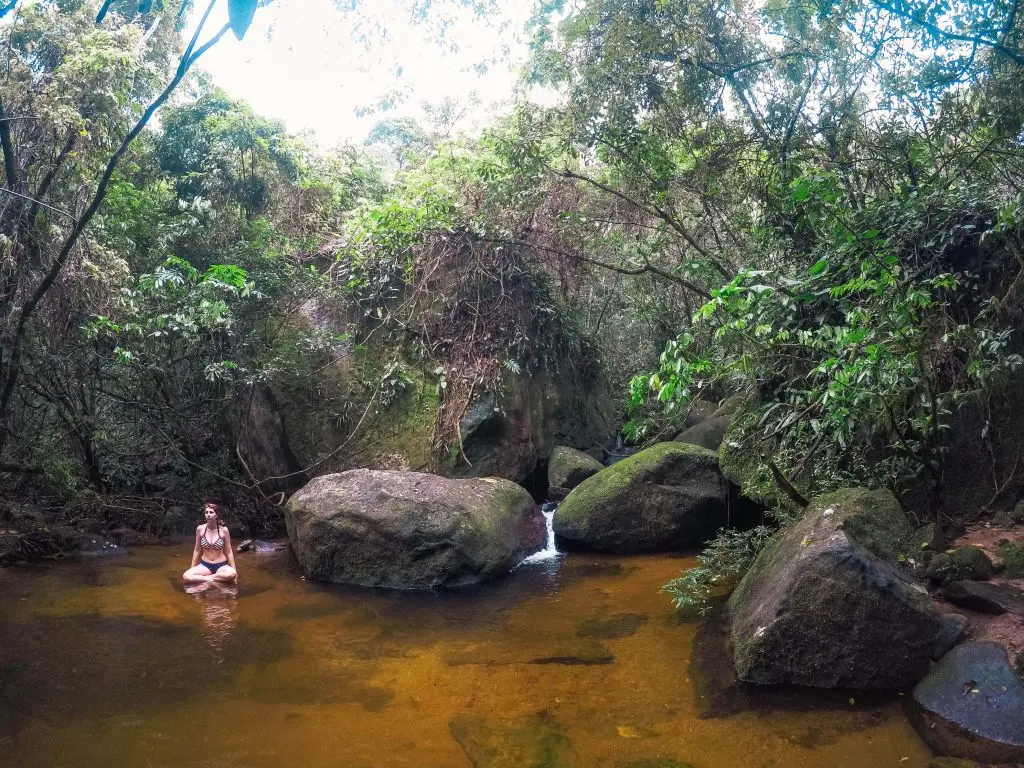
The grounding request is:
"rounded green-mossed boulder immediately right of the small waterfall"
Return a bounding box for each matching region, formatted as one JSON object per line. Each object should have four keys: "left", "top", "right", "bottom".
{"left": 554, "top": 442, "right": 730, "bottom": 553}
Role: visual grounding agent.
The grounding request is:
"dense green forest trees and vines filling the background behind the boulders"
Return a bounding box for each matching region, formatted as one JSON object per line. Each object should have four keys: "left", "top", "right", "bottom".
{"left": 0, "top": 0, "right": 1024, "bottom": 552}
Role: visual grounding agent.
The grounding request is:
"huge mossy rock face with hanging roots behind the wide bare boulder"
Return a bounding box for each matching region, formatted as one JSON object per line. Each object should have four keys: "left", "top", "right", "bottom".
{"left": 234, "top": 302, "right": 616, "bottom": 492}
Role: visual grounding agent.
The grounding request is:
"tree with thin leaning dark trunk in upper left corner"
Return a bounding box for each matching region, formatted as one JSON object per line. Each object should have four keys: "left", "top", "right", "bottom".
{"left": 0, "top": 0, "right": 257, "bottom": 456}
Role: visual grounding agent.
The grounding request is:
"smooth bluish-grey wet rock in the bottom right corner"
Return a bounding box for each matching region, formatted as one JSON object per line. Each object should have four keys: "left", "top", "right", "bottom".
{"left": 910, "top": 642, "right": 1024, "bottom": 763}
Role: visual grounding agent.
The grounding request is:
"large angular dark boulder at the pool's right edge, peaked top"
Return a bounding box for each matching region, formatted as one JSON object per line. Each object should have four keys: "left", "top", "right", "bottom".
{"left": 729, "top": 488, "right": 943, "bottom": 690}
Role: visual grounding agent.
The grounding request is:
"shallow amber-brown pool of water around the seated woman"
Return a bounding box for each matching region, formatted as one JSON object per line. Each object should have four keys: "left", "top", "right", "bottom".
{"left": 0, "top": 543, "right": 929, "bottom": 768}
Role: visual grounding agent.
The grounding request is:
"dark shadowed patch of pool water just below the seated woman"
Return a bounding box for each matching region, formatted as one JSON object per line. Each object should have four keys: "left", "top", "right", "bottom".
{"left": 0, "top": 601, "right": 294, "bottom": 735}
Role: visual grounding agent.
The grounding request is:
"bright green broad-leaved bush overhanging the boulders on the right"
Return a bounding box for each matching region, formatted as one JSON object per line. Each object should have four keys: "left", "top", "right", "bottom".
{"left": 634, "top": 187, "right": 1022, "bottom": 493}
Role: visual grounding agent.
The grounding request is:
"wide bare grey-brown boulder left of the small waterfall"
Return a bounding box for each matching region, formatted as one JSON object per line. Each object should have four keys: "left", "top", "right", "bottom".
{"left": 285, "top": 469, "right": 546, "bottom": 589}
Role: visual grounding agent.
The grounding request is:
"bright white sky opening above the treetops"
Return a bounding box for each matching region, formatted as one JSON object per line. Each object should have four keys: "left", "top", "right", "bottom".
{"left": 193, "top": 0, "right": 534, "bottom": 147}
